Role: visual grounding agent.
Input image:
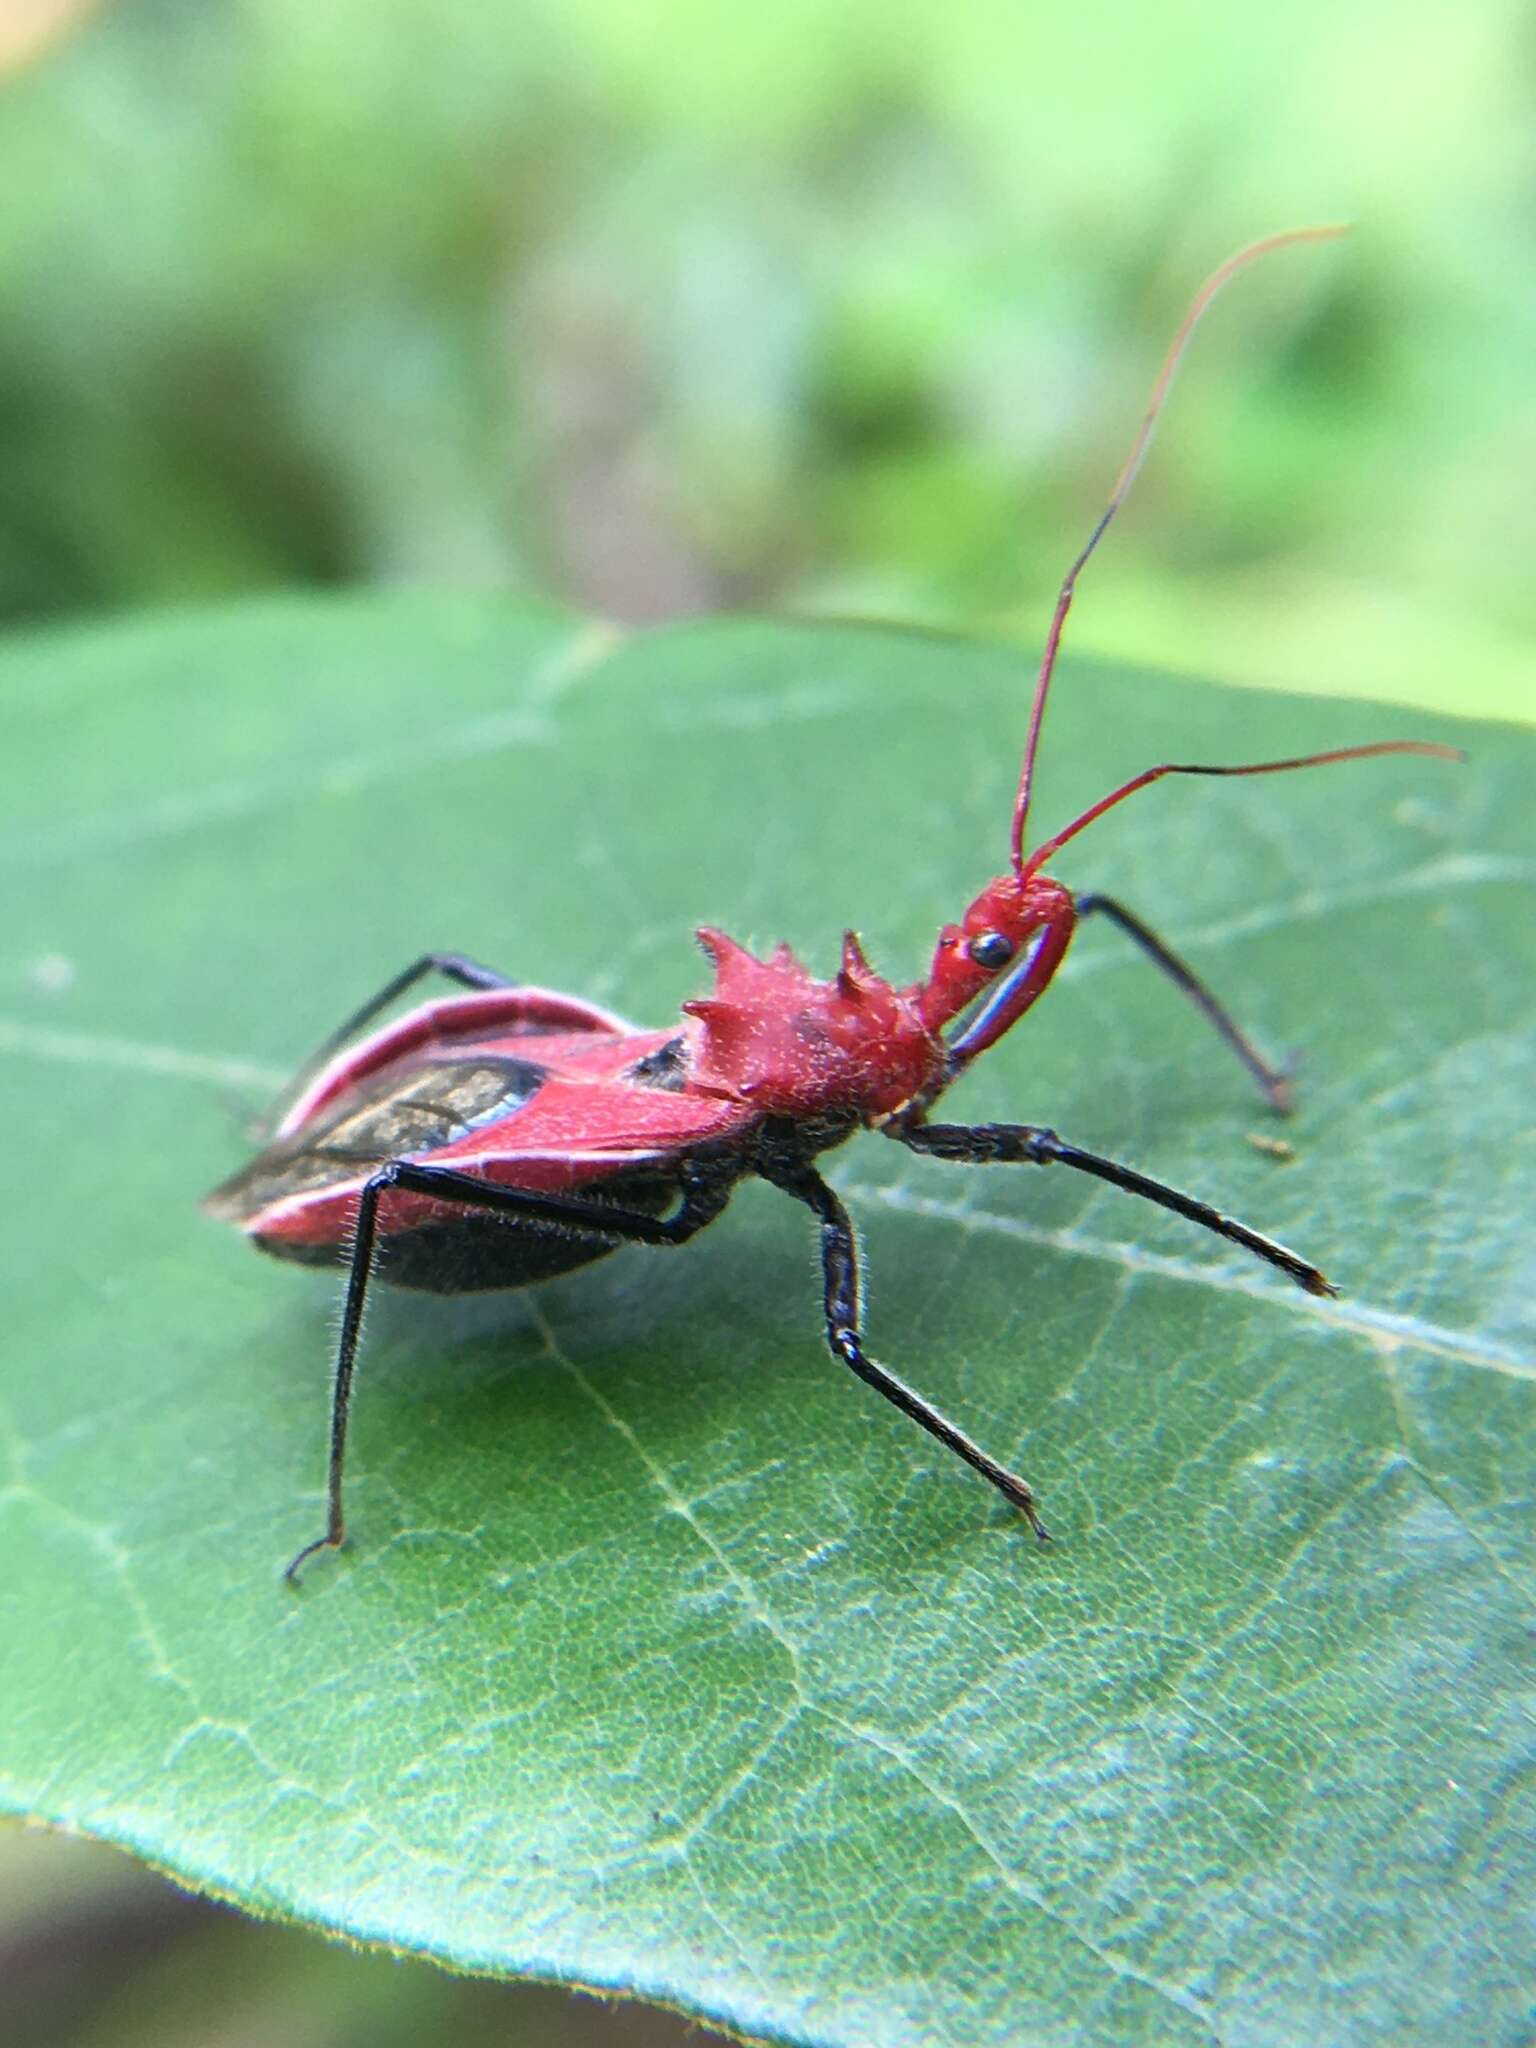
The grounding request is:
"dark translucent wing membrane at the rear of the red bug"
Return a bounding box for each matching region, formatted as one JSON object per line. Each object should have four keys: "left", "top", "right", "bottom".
{"left": 203, "top": 1053, "right": 547, "bottom": 1223}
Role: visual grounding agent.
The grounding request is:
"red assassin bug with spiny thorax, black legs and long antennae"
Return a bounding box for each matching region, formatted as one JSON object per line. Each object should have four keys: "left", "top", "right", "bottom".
{"left": 205, "top": 227, "right": 1456, "bottom": 1579}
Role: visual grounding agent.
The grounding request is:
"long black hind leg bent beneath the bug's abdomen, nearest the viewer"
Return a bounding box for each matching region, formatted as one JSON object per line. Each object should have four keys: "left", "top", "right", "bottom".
{"left": 285, "top": 1159, "right": 735, "bottom": 1585}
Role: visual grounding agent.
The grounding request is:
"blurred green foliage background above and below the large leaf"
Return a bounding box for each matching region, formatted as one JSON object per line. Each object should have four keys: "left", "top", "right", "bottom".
{"left": 0, "top": 0, "right": 1536, "bottom": 2048}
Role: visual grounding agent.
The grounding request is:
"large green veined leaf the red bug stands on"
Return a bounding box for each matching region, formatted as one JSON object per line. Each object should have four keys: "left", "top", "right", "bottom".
{"left": 0, "top": 598, "right": 1536, "bottom": 2048}
